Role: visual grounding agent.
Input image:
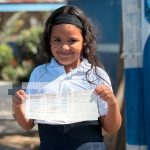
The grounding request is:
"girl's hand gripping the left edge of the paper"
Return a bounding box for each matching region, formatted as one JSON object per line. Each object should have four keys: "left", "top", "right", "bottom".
{"left": 12, "top": 90, "right": 27, "bottom": 109}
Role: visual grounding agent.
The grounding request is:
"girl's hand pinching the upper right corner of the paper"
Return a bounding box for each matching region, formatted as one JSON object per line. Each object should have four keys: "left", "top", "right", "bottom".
{"left": 95, "top": 84, "right": 116, "bottom": 106}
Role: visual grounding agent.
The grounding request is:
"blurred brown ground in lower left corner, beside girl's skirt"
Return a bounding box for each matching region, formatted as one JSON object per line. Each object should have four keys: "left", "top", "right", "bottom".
{"left": 0, "top": 119, "right": 39, "bottom": 150}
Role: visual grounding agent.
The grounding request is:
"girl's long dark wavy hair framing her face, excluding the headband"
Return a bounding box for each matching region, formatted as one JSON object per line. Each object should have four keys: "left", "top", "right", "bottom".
{"left": 41, "top": 5, "right": 106, "bottom": 82}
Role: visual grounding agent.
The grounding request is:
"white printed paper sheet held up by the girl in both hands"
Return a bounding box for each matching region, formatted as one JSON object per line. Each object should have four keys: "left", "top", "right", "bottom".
{"left": 25, "top": 90, "right": 99, "bottom": 124}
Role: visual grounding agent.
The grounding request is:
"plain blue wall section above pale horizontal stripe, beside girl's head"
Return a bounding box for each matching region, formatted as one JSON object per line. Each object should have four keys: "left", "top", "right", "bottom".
{"left": 68, "top": 0, "right": 121, "bottom": 43}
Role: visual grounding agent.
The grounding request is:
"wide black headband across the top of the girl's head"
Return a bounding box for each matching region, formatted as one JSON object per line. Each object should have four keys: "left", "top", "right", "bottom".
{"left": 53, "top": 14, "right": 83, "bottom": 28}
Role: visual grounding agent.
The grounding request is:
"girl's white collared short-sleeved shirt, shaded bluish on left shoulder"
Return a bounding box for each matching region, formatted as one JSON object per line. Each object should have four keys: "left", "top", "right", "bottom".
{"left": 27, "top": 58, "right": 112, "bottom": 124}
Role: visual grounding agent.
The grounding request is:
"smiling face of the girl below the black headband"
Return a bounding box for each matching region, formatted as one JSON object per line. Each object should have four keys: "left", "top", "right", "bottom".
{"left": 50, "top": 24, "right": 83, "bottom": 72}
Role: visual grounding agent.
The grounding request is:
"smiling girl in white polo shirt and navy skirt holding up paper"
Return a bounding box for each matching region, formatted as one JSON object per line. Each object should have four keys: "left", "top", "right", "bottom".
{"left": 13, "top": 5, "right": 121, "bottom": 150}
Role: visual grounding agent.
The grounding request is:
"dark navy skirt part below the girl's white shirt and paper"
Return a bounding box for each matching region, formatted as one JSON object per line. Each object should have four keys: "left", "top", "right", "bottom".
{"left": 38, "top": 122, "right": 103, "bottom": 150}
